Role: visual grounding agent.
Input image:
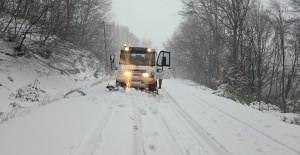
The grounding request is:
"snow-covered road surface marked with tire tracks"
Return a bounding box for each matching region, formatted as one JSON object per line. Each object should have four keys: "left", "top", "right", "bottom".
{"left": 0, "top": 79, "right": 300, "bottom": 155}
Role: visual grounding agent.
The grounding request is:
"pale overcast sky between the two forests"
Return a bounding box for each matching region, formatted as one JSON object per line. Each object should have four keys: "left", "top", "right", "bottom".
{"left": 112, "top": 0, "right": 181, "bottom": 50}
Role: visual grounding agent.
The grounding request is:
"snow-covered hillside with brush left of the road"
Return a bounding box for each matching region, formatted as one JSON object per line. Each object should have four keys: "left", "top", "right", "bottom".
{"left": 0, "top": 39, "right": 107, "bottom": 123}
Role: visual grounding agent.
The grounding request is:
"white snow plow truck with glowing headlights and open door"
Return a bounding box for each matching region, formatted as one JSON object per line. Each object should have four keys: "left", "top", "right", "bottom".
{"left": 107, "top": 45, "right": 171, "bottom": 93}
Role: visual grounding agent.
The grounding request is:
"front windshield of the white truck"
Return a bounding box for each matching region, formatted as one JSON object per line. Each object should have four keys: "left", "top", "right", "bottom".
{"left": 120, "top": 50, "right": 155, "bottom": 66}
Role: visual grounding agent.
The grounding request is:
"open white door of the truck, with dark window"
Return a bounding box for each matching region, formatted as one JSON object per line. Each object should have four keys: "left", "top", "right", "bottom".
{"left": 155, "top": 51, "right": 172, "bottom": 79}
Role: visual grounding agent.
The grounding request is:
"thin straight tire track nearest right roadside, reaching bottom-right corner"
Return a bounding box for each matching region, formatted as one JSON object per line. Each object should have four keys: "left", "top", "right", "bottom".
{"left": 180, "top": 89, "right": 300, "bottom": 154}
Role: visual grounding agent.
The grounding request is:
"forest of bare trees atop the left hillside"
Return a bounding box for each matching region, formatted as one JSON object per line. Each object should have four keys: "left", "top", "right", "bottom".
{"left": 0, "top": 0, "right": 146, "bottom": 69}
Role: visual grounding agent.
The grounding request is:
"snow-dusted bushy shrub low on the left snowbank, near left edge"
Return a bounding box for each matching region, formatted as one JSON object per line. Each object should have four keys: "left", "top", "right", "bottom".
{"left": 15, "top": 80, "right": 45, "bottom": 102}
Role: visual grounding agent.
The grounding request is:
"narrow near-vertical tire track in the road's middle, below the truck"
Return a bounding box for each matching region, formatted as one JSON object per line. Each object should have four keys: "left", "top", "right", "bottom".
{"left": 133, "top": 109, "right": 145, "bottom": 155}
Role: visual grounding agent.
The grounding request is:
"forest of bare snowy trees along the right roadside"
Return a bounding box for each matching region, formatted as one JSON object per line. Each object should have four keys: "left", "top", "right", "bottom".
{"left": 165, "top": 0, "right": 300, "bottom": 112}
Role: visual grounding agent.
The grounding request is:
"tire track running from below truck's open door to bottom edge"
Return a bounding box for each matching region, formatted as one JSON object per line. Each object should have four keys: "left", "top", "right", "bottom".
{"left": 166, "top": 92, "right": 230, "bottom": 154}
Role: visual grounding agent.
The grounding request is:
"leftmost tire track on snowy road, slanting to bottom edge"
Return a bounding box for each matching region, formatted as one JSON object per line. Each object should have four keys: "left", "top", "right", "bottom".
{"left": 74, "top": 108, "right": 112, "bottom": 155}
